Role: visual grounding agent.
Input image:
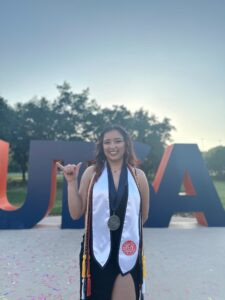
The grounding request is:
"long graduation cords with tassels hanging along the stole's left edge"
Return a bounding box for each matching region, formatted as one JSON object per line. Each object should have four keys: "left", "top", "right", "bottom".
{"left": 81, "top": 174, "right": 95, "bottom": 300}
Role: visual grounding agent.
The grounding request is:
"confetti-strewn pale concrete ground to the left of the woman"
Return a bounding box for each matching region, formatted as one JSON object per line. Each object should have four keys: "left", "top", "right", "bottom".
{"left": 0, "top": 227, "right": 83, "bottom": 300}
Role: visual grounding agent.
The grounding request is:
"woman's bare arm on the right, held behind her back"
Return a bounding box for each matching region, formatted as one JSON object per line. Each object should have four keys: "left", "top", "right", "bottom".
{"left": 137, "top": 169, "right": 150, "bottom": 224}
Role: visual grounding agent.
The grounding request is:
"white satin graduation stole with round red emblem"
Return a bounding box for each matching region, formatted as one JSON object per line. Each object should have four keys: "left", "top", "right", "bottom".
{"left": 92, "top": 167, "right": 141, "bottom": 274}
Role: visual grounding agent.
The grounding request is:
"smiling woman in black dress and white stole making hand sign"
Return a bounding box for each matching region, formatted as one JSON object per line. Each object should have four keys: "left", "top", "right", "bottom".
{"left": 59, "top": 126, "right": 149, "bottom": 300}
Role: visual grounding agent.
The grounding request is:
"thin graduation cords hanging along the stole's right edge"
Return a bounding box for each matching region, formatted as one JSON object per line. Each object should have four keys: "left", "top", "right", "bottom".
{"left": 128, "top": 165, "right": 147, "bottom": 299}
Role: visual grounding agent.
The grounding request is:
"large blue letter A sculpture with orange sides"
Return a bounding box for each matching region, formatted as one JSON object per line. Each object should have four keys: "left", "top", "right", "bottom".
{"left": 146, "top": 144, "right": 225, "bottom": 227}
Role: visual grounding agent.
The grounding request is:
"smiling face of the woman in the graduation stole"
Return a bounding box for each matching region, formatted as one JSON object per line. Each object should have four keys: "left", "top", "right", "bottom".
{"left": 103, "top": 130, "right": 126, "bottom": 162}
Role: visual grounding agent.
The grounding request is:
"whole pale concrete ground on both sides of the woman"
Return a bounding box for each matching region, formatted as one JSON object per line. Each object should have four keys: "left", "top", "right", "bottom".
{"left": 0, "top": 217, "right": 225, "bottom": 300}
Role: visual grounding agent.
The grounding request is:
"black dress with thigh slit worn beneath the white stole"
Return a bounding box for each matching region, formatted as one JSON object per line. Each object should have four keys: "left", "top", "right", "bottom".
{"left": 80, "top": 166, "right": 142, "bottom": 300}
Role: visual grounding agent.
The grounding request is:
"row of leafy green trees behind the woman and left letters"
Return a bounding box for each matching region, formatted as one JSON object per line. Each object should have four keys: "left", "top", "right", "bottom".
{"left": 0, "top": 82, "right": 174, "bottom": 181}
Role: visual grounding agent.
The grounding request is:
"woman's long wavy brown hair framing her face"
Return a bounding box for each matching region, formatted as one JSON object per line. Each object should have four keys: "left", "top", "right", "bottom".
{"left": 95, "top": 125, "right": 138, "bottom": 175}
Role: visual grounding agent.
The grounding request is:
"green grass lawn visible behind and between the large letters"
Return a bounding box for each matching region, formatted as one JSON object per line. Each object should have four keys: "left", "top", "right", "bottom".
{"left": 2, "top": 173, "right": 225, "bottom": 215}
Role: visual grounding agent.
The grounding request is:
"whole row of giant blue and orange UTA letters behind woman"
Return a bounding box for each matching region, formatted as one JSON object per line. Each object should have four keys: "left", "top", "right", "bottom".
{"left": 0, "top": 141, "right": 225, "bottom": 229}
